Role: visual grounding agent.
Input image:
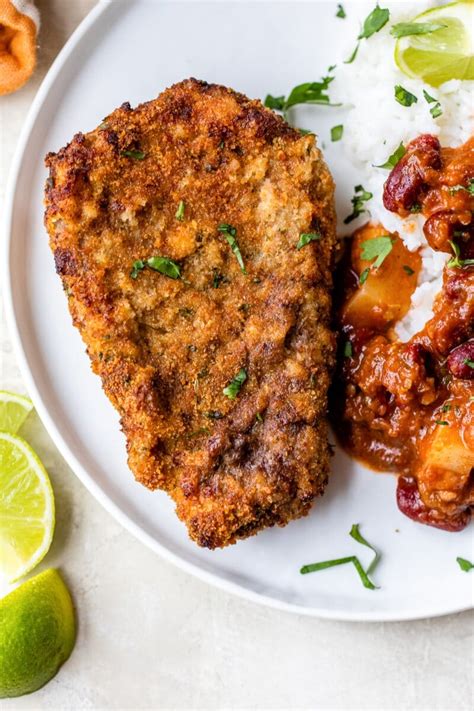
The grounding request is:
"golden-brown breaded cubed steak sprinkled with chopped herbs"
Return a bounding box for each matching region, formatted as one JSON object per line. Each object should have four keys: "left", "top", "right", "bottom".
{"left": 45, "top": 79, "right": 335, "bottom": 548}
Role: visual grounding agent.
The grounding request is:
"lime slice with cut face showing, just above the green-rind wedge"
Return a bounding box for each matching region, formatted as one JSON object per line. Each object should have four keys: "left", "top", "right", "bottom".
{"left": 0, "top": 432, "right": 54, "bottom": 582}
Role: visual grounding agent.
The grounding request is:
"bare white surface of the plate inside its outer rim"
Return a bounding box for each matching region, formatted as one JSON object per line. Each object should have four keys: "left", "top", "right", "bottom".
{"left": 4, "top": 0, "right": 474, "bottom": 620}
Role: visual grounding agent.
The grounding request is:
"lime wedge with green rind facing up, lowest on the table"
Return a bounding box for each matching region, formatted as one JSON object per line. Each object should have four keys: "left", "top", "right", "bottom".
{"left": 0, "top": 569, "right": 76, "bottom": 698}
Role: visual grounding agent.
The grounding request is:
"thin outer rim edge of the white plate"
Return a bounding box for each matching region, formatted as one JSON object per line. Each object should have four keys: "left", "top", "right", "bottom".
{"left": 1, "top": 0, "right": 474, "bottom": 622}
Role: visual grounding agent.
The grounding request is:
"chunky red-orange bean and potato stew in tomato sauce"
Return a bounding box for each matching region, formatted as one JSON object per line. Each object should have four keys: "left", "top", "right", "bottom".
{"left": 331, "top": 135, "right": 474, "bottom": 531}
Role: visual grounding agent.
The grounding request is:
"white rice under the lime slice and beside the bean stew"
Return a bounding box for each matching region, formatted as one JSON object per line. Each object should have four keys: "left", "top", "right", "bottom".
{"left": 331, "top": 1, "right": 474, "bottom": 341}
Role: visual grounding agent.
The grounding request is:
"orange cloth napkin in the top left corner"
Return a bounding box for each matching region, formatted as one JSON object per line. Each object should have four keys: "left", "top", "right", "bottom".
{"left": 0, "top": 0, "right": 39, "bottom": 94}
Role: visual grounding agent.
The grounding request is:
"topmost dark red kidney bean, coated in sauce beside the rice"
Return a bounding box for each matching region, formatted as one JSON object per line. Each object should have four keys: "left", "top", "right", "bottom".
{"left": 383, "top": 133, "right": 441, "bottom": 214}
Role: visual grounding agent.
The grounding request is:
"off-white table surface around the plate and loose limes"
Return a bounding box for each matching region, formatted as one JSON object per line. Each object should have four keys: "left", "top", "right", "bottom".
{"left": 0, "top": 0, "right": 474, "bottom": 711}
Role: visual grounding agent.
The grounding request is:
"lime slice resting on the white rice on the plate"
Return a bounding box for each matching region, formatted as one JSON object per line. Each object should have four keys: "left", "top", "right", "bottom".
{"left": 395, "top": 0, "right": 474, "bottom": 86}
